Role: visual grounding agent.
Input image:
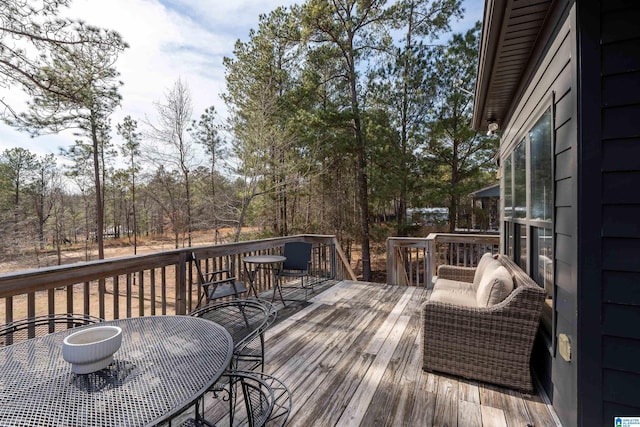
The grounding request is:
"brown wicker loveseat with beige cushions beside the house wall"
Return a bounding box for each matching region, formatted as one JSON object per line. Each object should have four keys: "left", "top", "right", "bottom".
{"left": 423, "top": 255, "right": 545, "bottom": 393}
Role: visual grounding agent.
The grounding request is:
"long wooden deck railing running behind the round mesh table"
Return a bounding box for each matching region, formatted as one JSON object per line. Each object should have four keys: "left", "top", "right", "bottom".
{"left": 0, "top": 235, "right": 355, "bottom": 323}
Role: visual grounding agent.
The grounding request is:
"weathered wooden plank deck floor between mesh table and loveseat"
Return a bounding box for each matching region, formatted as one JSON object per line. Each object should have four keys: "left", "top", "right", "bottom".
{"left": 195, "top": 281, "right": 559, "bottom": 427}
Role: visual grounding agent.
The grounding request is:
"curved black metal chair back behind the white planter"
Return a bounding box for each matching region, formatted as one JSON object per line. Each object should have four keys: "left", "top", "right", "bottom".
{"left": 0, "top": 313, "right": 103, "bottom": 347}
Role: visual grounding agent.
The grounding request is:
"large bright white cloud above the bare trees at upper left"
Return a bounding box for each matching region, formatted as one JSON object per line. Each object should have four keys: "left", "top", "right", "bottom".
{"left": 69, "top": 0, "right": 230, "bottom": 122}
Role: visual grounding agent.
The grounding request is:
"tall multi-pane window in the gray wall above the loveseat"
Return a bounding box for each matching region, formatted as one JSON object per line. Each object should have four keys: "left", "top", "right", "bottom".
{"left": 502, "top": 109, "right": 554, "bottom": 331}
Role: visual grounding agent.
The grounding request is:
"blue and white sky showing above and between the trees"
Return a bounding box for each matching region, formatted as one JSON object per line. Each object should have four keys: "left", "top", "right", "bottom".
{"left": 0, "top": 0, "right": 484, "bottom": 160}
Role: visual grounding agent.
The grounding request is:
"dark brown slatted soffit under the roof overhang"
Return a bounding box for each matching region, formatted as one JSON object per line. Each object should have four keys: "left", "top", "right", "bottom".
{"left": 473, "top": 0, "right": 554, "bottom": 130}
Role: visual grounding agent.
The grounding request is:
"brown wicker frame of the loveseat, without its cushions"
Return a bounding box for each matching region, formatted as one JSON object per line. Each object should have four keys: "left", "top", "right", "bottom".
{"left": 423, "top": 255, "right": 545, "bottom": 393}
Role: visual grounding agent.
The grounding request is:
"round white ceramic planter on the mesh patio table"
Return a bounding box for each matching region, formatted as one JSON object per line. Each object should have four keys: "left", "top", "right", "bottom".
{"left": 62, "top": 326, "right": 122, "bottom": 374}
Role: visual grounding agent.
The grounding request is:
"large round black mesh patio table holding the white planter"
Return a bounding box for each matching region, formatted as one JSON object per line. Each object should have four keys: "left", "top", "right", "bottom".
{"left": 0, "top": 316, "right": 233, "bottom": 426}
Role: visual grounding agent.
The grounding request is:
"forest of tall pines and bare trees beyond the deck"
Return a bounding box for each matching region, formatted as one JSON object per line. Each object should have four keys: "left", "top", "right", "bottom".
{"left": 0, "top": 0, "right": 498, "bottom": 280}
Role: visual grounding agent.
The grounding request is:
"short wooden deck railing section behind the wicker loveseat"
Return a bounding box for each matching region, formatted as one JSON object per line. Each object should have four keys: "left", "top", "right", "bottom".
{"left": 387, "top": 233, "right": 500, "bottom": 286}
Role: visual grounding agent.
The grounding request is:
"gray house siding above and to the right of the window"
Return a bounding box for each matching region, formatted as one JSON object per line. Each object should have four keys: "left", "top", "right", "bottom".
{"left": 501, "top": 5, "right": 579, "bottom": 426}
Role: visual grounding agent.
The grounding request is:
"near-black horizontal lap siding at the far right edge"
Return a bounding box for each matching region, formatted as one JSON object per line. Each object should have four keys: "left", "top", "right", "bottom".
{"left": 600, "top": 0, "right": 640, "bottom": 423}
